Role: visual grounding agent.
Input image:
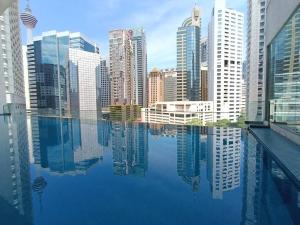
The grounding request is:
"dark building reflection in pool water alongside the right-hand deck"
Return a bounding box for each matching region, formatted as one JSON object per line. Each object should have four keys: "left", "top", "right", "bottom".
{"left": 241, "top": 132, "right": 300, "bottom": 225}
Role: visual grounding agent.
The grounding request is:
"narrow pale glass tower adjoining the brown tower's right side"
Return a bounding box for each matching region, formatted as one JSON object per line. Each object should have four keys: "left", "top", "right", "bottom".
{"left": 132, "top": 28, "right": 147, "bottom": 107}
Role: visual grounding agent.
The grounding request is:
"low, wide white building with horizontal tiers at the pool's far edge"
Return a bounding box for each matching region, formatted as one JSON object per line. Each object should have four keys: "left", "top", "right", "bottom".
{"left": 142, "top": 101, "right": 213, "bottom": 125}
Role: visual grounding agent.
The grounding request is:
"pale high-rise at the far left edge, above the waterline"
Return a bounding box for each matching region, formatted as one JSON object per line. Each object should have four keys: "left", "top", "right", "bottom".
{"left": 0, "top": 2, "right": 25, "bottom": 114}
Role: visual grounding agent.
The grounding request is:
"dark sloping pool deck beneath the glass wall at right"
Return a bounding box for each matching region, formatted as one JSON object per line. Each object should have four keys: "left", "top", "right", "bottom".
{"left": 249, "top": 128, "right": 300, "bottom": 187}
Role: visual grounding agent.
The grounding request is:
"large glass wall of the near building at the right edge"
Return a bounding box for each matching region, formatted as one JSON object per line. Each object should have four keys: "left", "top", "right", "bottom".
{"left": 267, "top": 7, "right": 300, "bottom": 124}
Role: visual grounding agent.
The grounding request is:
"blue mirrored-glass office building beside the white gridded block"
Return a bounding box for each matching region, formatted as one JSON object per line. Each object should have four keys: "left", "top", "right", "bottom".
{"left": 27, "top": 31, "right": 99, "bottom": 116}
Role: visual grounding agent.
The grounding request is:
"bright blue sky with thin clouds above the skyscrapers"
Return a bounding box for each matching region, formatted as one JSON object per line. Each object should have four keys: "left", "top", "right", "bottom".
{"left": 20, "top": 0, "right": 246, "bottom": 69}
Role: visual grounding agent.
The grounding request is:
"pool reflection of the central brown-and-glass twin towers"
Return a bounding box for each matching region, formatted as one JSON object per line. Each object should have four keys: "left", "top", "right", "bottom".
{"left": 111, "top": 122, "right": 148, "bottom": 177}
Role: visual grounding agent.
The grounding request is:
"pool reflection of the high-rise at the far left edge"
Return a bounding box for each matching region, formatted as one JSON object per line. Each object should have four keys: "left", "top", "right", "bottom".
{"left": 0, "top": 112, "right": 33, "bottom": 225}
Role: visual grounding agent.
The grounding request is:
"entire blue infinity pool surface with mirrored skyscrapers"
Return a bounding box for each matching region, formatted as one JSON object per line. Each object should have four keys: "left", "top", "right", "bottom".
{"left": 0, "top": 115, "right": 300, "bottom": 225}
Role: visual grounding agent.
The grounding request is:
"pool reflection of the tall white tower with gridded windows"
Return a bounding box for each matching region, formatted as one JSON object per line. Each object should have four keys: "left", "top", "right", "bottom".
{"left": 207, "top": 128, "right": 241, "bottom": 199}
